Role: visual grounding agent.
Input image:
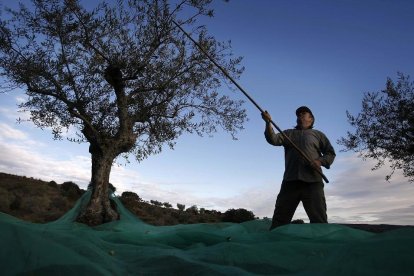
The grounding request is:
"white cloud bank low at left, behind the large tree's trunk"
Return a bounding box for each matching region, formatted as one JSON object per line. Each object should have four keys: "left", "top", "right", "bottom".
{"left": 0, "top": 122, "right": 169, "bottom": 197}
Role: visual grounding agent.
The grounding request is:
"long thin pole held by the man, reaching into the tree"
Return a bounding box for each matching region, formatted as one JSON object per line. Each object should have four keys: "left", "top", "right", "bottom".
{"left": 172, "top": 20, "right": 329, "bottom": 183}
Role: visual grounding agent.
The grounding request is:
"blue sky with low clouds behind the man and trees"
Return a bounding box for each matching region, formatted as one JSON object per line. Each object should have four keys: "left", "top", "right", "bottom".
{"left": 0, "top": 0, "right": 414, "bottom": 225}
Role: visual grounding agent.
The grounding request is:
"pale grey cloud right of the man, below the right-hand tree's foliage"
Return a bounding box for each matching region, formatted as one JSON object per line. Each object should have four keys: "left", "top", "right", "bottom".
{"left": 325, "top": 155, "right": 414, "bottom": 224}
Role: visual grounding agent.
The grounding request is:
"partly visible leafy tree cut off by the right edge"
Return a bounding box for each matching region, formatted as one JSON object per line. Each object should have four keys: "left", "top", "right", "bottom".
{"left": 338, "top": 73, "right": 414, "bottom": 182}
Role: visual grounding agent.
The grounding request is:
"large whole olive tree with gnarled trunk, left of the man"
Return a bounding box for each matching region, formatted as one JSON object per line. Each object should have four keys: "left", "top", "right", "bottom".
{"left": 0, "top": 0, "right": 246, "bottom": 225}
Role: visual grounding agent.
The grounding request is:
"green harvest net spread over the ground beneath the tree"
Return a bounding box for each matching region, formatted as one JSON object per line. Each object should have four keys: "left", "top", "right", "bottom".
{"left": 0, "top": 193, "right": 414, "bottom": 275}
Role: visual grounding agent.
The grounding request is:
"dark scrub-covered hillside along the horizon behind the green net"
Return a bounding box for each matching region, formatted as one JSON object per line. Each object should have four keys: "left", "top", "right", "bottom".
{"left": 0, "top": 173, "right": 414, "bottom": 233}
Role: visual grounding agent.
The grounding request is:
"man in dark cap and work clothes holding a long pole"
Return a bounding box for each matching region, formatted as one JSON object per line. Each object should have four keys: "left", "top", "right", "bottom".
{"left": 262, "top": 106, "right": 336, "bottom": 230}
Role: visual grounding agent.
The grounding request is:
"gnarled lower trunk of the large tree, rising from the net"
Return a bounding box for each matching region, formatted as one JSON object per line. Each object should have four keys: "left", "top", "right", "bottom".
{"left": 76, "top": 149, "right": 119, "bottom": 226}
